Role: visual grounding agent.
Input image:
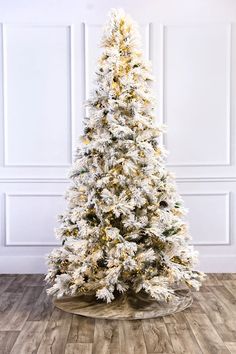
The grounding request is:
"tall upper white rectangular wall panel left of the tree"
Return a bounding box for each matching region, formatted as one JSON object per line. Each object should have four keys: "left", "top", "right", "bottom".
{"left": 3, "top": 25, "right": 72, "bottom": 166}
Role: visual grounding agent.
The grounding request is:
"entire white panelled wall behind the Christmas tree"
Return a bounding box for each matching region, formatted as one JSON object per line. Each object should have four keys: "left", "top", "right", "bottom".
{"left": 0, "top": 0, "right": 236, "bottom": 273}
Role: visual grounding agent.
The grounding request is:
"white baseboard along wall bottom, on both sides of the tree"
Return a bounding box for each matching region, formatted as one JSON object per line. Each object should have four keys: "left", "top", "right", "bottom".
{"left": 0, "top": 255, "right": 236, "bottom": 274}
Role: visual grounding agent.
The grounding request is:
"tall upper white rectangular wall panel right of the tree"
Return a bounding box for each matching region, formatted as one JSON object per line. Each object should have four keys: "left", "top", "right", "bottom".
{"left": 164, "top": 24, "right": 231, "bottom": 166}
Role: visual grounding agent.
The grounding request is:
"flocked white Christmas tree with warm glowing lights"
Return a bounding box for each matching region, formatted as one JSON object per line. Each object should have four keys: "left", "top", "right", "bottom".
{"left": 46, "top": 10, "right": 204, "bottom": 302}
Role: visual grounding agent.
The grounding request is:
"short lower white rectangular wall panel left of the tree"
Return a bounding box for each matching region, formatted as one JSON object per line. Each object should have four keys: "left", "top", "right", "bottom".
{"left": 5, "top": 194, "right": 65, "bottom": 246}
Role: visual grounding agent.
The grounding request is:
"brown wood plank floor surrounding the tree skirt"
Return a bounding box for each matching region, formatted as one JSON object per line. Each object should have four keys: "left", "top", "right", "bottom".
{"left": 0, "top": 273, "right": 236, "bottom": 354}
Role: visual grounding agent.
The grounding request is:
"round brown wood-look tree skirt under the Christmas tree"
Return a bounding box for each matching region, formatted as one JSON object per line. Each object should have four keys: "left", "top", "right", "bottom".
{"left": 54, "top": 289, "right": 193, "bottom": 320}
